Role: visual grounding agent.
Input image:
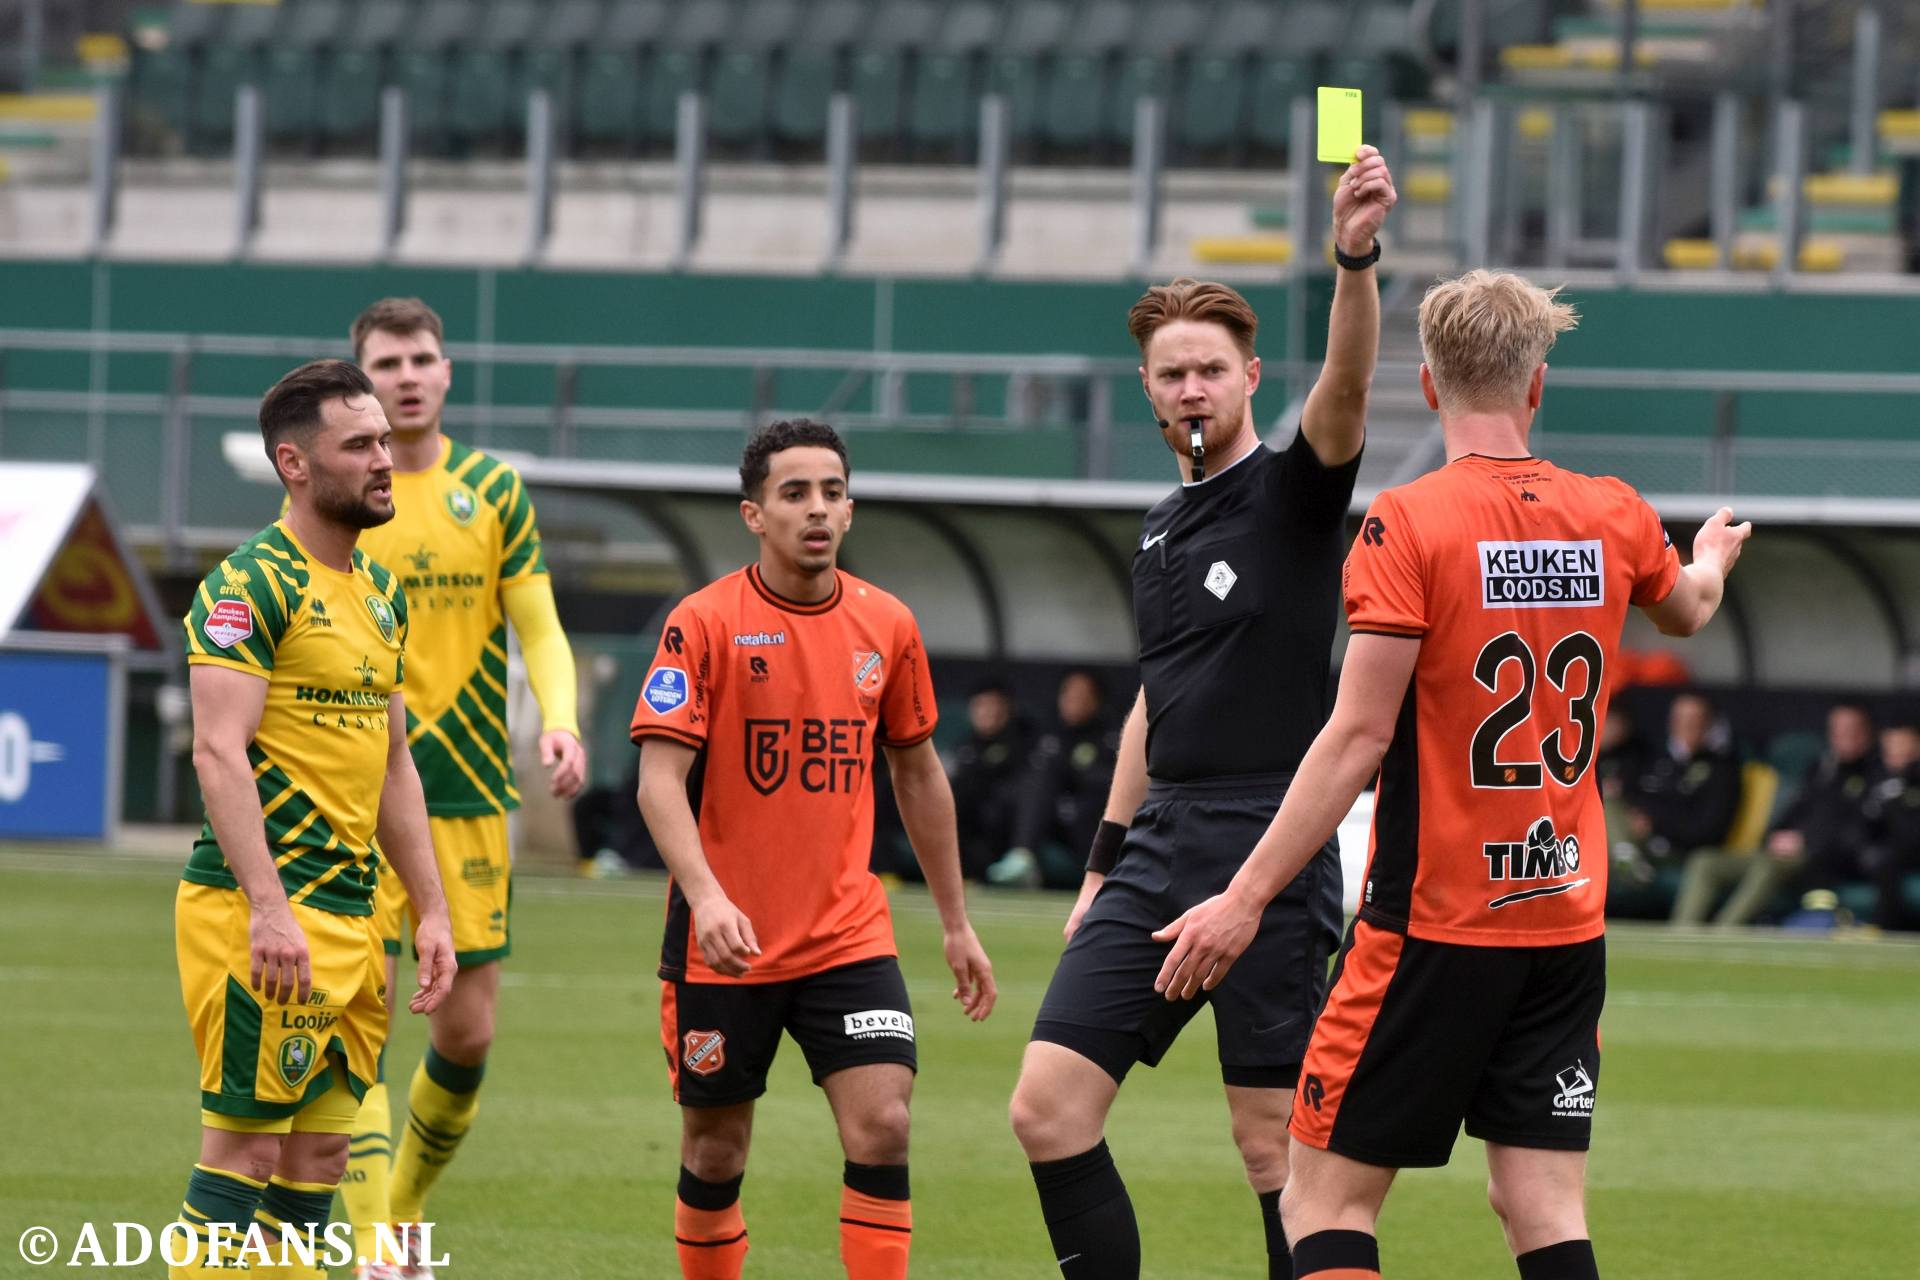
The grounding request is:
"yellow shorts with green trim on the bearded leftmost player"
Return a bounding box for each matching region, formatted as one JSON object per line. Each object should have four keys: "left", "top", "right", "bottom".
{"left": 173, "top": 883, "right": 386, "bottom": 1132}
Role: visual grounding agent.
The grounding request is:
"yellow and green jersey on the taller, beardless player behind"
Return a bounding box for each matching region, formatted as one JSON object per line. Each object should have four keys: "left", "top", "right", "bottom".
{"left": 361, "top": 438, "right": 547, "bottom": 818}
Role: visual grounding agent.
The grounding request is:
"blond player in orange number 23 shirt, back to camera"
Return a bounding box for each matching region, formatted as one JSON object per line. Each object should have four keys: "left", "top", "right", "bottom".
{"left": 1156, "top": 271, "right": 1753, "bottom": 1280}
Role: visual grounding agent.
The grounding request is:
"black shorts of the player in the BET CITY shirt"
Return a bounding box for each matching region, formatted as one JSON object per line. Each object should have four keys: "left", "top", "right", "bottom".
{"left": 660, "top": 956, "right": 918, "bottom": 1107}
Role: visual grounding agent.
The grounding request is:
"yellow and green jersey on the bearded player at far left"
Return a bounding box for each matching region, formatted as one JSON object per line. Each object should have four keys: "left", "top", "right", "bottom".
{"left": 182, "top": 520, "right": 407, "bottom": 915}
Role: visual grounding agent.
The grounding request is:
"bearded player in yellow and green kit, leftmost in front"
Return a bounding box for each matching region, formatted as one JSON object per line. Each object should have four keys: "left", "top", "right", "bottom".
{"left": 167, "top": 361, "right": 453, "bottom": 1280}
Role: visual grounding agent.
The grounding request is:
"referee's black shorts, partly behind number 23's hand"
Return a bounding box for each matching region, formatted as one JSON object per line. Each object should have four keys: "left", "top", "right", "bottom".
{"left": 1033, "top": 775, "right": 1340, "bottom": 1088}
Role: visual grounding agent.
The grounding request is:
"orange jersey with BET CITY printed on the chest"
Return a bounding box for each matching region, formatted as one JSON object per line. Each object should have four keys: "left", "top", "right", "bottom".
{"left": 634, "top": 566, "right": 937, "bottom": 983}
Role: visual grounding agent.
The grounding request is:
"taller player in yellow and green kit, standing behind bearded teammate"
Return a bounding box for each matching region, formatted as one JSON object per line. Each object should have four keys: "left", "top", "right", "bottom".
{"left": 346, "top": 297, "right": 586, "bottom": 1276}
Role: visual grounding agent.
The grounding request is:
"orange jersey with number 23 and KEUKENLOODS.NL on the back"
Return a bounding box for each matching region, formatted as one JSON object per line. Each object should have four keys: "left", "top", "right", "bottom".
{"left": 1346, "top": 455, "right": 1680, "bottom": 946}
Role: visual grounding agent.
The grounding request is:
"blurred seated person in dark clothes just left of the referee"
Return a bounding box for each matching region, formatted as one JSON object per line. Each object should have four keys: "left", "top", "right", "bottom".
{"left": 987, "top": 670, "right": 1119, "bottom": 889}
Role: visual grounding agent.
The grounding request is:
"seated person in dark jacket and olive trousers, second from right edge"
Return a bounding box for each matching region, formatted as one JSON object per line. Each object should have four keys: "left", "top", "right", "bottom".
{"left": 1674, "top": 702, "right": 1882, "bottom": 925}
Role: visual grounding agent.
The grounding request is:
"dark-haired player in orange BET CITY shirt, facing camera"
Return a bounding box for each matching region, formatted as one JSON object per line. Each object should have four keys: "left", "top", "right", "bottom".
{"left": 634, "top": 420, "right": 995, "bottom": 1280}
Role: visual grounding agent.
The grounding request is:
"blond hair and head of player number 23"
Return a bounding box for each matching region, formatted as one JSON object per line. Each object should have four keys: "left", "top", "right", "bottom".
{"left": 1421, "top": 269, "right": 1580, "bottom": 413}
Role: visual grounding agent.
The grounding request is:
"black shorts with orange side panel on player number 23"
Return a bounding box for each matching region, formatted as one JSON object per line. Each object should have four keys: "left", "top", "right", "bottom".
{"left": 1288, "top": 919, "right": 1607, "bottom": 1169}
